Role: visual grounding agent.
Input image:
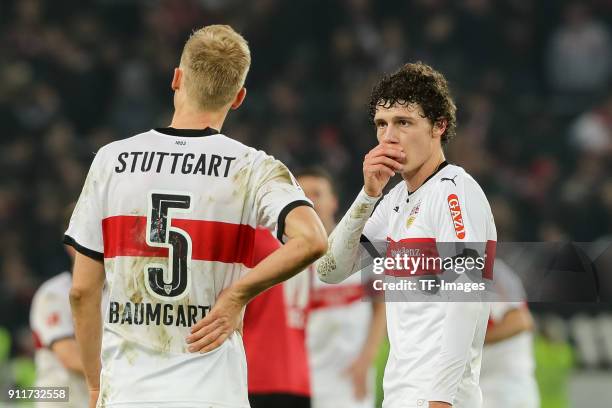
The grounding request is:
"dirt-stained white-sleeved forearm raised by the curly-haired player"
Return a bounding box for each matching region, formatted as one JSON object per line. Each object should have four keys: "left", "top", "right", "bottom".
{"left": 316, "top": 189, "right": 380, "bottom": 283}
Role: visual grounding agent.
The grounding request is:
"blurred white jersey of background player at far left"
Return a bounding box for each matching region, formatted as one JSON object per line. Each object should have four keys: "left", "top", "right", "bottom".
{"left": 30, "top": 272, "right": 89, "bottom": 408}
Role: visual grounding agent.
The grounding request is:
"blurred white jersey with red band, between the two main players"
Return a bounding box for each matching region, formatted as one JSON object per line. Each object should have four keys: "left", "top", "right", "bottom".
{"left": 306, "top": 273, "right": 374, "bottom": 408}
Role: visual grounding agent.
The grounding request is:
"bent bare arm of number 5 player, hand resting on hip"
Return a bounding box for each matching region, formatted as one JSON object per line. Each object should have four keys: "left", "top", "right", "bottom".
{"left": 187, "top": 206, "right": 327, "bottom": 353}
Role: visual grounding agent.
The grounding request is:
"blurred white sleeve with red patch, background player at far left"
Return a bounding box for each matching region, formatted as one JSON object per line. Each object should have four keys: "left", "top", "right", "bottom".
{"left": 30, "top": 287, "right": 74, "bottom": 348}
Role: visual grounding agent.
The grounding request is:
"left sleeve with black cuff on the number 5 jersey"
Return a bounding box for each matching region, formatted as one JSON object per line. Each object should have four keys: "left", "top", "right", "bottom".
{"left": 64, "top": 152, "right": 104, "bottom": 261}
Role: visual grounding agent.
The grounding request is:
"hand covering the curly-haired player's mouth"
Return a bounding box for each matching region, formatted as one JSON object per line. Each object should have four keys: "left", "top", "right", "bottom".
{"left": 363, "top": 143, "right": 406, "bottom": 197}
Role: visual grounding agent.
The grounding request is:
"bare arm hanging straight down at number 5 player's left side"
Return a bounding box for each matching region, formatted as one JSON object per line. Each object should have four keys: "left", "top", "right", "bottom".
{"left": 70, "top": 253, "right": 104, "bottom": 407}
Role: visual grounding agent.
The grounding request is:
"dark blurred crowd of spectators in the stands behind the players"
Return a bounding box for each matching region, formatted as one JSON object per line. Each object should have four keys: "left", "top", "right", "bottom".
{"left": 0, "top": 0, "right": 612, "bottom": 362}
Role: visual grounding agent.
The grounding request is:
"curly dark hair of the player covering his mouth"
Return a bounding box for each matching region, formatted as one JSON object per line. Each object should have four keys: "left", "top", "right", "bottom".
{"left": 368, "top": 61, "right": 457, "bottom": 144}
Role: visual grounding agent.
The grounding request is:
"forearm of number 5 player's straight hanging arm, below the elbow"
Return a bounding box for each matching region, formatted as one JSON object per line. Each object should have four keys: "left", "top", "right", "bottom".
{"left": 70, "top": 288, "right": 102, "bottom": 389}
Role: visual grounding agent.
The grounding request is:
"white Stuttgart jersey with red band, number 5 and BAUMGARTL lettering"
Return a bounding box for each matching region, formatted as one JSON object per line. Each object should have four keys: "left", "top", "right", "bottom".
{"left": 65, "top": 128, "right": 311, "bottom": 407}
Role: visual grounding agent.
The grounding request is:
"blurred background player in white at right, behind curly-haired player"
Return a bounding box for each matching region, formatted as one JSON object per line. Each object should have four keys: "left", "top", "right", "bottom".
{"left": 480, "top": 258, "right": 540, "bottom": 408}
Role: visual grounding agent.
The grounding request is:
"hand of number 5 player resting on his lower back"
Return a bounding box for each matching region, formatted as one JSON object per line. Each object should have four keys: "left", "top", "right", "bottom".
{"left": 186, "top": 288, "right": 244, "bottom": 353}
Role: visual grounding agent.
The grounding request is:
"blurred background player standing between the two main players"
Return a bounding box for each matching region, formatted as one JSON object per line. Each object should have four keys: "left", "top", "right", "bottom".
{"left": 296, "top": 167, "right": 386, "bottom": 408}
